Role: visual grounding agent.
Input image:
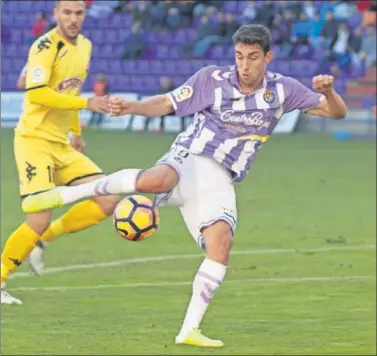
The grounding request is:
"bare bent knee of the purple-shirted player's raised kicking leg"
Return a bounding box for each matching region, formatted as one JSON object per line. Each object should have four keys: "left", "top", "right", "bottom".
{"left": 136, "top": 165, "right": 178, "bottom": 194}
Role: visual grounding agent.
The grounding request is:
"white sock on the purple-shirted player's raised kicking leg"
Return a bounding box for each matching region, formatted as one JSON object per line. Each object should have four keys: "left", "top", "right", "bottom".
{"left": 60, "top": 169, "right": 141, "bottom": 204}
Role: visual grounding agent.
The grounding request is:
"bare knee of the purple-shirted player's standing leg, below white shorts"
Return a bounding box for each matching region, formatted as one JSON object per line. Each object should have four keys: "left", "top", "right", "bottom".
{"left": 202, "top": 221, "right": 233, "bottom": 265}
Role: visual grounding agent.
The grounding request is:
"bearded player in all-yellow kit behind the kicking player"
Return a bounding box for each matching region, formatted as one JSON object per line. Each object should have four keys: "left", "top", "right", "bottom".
{"left": 1, "top": 0, "right": 118, "bottom": 304}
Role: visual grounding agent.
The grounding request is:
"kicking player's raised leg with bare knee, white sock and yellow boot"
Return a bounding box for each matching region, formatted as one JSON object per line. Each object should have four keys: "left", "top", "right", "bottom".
{"left": 22, "top": 165, "right": 178, "bottom": 213}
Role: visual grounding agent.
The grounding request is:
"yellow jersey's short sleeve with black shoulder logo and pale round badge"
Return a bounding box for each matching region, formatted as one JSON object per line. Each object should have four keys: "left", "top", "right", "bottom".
{"left": 26, "top": 37, "right": 56, "bottom": 90}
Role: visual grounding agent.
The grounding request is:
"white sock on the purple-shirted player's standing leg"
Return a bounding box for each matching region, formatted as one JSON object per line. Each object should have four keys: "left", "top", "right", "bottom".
{"left": 177, "top": 258, "right": 227, "bottom": 340}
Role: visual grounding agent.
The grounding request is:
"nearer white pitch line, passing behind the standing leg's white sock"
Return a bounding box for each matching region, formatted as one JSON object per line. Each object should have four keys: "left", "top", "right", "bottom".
{"left": 9, "top": 276, "right": 376, "bottom": 292}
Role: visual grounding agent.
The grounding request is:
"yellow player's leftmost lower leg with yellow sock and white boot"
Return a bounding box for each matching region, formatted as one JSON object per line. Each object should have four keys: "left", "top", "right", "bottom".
{"left": 1, "top": 211, "right": 51, "bottom": 304}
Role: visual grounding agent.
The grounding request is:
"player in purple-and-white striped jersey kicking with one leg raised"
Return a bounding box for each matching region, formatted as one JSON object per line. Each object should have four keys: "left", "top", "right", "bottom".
{"left": 23, "top": 25, "right": 347, "bottom": 347}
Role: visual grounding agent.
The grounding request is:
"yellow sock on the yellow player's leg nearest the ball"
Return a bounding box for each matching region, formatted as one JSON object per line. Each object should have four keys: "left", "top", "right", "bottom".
{"left": 41, "top": 200, "right": 107, "bottom": 242}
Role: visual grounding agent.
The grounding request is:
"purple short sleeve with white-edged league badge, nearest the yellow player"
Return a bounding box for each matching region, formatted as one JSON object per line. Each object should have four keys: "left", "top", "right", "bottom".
{"left": 167, "top": 67, "right": 214, "bottom": 116}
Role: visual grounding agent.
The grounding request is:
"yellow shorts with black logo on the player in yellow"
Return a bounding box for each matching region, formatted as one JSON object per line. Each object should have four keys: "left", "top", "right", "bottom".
{"left": 14, "top": 134, "right": 102, "bottom": 198}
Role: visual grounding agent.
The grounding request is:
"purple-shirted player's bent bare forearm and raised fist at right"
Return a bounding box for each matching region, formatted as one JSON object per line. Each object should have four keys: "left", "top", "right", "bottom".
{"left": 308, "top": 75, "right": 347, "bottom": 120}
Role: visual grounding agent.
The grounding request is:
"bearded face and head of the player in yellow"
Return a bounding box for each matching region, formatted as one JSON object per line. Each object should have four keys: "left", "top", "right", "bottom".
{"left": 54, "top": 0, "right": 86, "bottom": 40}
